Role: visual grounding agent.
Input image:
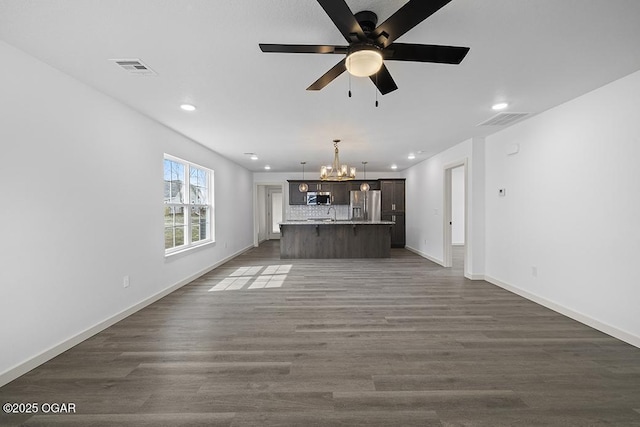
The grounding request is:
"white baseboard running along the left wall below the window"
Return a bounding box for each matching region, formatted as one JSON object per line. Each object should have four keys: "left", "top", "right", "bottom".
{"left": 0, "top": 244, "right": 253, "bottom": 387}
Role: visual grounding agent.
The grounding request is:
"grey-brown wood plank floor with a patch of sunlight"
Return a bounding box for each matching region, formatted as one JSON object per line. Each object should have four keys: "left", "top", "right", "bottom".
{"left": 0, "top": 242, "right": 640, "bottom": 427}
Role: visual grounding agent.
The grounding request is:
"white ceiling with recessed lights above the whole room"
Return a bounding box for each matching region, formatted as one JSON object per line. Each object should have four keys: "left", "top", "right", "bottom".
{"left": 0, "top": 0, "right": 640, "bottom": 172}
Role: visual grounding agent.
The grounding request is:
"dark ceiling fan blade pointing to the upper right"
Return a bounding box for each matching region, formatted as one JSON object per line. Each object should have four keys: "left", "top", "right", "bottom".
{"left": 370, "top": 0, "right": 451, "bottom": 47}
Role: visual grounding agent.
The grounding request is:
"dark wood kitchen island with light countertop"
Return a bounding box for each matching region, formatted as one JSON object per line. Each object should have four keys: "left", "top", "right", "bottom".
{"left": 280, "top": 219, "right": 394, "bottom": 259}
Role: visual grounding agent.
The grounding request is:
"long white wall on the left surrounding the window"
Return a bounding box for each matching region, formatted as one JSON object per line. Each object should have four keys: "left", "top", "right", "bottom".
{"left": 0, "top": 42, "right": 253, "bottom": 385}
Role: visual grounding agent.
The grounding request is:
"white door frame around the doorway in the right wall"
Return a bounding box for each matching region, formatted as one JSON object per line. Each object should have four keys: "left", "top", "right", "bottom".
{"left": 442, "top": 158, "right": 469, "bottom": 267}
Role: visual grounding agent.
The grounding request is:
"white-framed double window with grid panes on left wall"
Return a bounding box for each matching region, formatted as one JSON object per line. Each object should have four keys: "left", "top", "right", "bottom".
{"left": 164, "top": 155, "right": 213, "bottom": 254}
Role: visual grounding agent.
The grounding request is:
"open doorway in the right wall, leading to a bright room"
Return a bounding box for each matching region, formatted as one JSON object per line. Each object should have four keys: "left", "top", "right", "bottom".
{"left": 443, "top": 160, "right": 467, "bottom": 268}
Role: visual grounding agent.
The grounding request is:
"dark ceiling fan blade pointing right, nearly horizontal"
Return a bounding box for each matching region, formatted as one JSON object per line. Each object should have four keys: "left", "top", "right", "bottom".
{"left": 382, "top": 43, "right": 469, "bottom": 64}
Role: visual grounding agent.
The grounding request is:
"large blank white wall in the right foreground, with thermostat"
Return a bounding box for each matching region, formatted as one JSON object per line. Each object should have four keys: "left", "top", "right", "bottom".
{"left": 486, "top": 68, "right": 640, "bottom": 346}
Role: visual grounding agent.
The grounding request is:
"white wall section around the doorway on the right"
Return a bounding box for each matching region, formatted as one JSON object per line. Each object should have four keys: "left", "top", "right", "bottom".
{"left": 405, "top": 138, "right": 484, "bottom": 279}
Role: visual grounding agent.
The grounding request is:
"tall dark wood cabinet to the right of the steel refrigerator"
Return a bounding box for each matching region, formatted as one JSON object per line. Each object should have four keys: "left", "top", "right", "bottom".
{"left": 380, "top": 179, "right": 407, "bottom": 248}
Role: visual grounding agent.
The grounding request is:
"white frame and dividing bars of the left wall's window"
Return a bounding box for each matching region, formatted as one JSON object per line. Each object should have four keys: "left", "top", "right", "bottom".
{"left": 162, "top": 153, "right": 215, "bottom": 256}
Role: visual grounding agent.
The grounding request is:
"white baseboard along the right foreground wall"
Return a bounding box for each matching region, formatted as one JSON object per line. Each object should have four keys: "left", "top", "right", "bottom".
{"left": 484, "top": 275, "right": 640, "bottom": 348}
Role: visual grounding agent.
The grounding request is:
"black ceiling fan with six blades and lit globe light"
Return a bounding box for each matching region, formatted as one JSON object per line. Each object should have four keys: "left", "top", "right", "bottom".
{"left": 259, "top": 0, "right": 469, "bottom": 95}
